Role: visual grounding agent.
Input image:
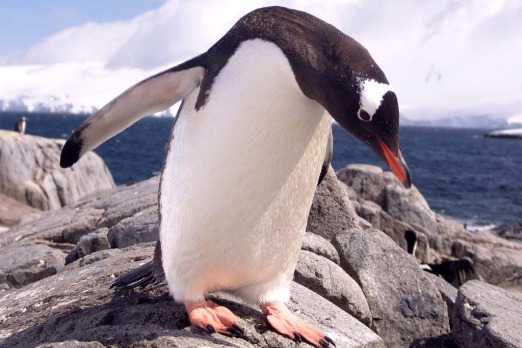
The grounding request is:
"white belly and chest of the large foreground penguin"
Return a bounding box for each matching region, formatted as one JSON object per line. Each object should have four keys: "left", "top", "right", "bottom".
{"left": 160, "top": 40, "right": 331, "bottom": 301}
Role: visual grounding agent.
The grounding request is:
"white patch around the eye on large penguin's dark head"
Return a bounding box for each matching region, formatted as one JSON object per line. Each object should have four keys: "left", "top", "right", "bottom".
{"left": 357, "top": 78, "right": 392, "bottom": 122}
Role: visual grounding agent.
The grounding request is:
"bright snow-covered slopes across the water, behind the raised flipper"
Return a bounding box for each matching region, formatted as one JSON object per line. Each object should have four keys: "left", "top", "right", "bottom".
{"left": 0, "top": 61, "right": 177, "bottom": 115}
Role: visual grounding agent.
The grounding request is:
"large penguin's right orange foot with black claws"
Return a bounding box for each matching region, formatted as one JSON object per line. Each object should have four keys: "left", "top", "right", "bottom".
{"left": 261, "top": 302, "right": 335, "bottom": 348}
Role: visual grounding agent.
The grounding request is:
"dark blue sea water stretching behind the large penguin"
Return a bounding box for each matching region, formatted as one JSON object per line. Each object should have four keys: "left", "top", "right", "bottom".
{"left": 0, "top": 113, "right": 522, "bottom": 226}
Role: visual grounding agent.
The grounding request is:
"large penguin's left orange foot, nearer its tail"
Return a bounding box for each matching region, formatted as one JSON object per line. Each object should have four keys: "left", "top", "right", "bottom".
{"left": 185, "top": 301, "right": 243, "bottom": 336}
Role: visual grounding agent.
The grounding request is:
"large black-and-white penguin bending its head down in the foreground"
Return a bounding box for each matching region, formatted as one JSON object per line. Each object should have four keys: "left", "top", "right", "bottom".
{"left": 60, "top": 7, "right": 411, "bottom": 347}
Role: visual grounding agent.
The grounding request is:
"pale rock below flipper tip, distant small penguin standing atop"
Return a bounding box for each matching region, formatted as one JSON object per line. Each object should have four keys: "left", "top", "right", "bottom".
{"left": 0, "top": 130, "right": 114, "bottom": 210}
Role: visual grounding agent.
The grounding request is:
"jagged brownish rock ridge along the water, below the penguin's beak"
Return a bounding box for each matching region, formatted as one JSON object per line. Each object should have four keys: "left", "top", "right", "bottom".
{"left": 338, "top": 164, "right": 522, "bottom": 287}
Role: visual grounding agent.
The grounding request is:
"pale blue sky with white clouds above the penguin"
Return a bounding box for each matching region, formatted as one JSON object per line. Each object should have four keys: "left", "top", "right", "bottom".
{"left": 0, "top": 0, "right": 522, "bottom": 122}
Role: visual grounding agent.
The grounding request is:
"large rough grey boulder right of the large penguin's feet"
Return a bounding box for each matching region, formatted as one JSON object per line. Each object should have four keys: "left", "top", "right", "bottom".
{"left": 334, "top": 229, "right": 449, "bottom": 347}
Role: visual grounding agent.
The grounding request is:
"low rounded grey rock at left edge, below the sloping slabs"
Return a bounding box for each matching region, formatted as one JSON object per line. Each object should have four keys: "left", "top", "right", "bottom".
{"left": 0, "top": 243, "right": 66, "bottom": 289}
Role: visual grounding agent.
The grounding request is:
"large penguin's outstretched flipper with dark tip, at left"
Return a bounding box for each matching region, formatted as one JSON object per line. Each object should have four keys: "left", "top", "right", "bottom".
{"left": 60, "top": 56, "right": 205, "bottom": 168}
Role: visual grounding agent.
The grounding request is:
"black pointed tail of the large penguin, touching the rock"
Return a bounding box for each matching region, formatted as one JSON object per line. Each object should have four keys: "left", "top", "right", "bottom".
{"left": 111, "top": 240, "right": 165, "bottom": 289}
